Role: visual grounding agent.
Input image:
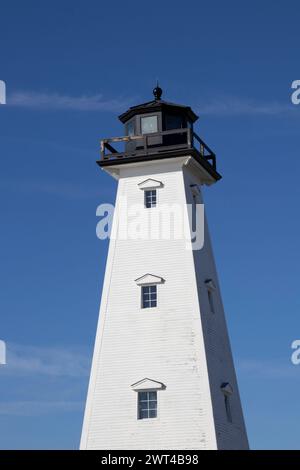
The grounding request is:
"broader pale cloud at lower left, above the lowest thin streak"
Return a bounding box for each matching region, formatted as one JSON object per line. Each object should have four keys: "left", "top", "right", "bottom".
{"left": 0, "top": 344, "right": 90, "bottom": 378}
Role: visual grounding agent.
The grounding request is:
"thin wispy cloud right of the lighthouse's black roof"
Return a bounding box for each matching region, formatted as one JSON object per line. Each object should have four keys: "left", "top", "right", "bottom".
{"left": 197, "top": 97, "right": 299, "bottom": 116}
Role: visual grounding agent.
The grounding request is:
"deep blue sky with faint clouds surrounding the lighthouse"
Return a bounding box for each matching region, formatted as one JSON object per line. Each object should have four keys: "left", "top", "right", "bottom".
{"left": 0, "top": 0, "right": 300, "bottom": 449}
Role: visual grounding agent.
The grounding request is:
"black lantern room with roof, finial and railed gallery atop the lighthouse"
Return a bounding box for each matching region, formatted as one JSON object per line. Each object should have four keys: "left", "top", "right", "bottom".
{"left": 98, "top": 84, "right": 221, "bottom": 181}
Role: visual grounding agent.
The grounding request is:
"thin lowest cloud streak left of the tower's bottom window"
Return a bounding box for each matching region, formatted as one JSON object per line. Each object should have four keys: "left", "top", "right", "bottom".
{"left": 0, "top": 400, "right": 84, "bottom": 416}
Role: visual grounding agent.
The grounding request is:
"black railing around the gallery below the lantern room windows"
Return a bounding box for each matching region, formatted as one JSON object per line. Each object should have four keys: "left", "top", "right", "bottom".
{"left": 101, "top": 128, "right": 216, "bottom": 169}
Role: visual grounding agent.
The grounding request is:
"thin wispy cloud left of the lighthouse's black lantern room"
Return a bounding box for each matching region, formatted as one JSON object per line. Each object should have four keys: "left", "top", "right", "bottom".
{"left": 7, "top": 91, "right": 131, "bottom": 112}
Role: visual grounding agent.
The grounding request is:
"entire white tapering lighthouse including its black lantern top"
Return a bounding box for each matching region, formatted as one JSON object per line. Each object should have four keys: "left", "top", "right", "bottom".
{"left": 80, "top": 86, "right": 248, "bottom": 450}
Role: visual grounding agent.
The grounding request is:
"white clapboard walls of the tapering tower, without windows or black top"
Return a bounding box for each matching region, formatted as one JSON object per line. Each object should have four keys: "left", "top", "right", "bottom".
{"left": 80, "top": 156, "right": 248, "bottom": 450}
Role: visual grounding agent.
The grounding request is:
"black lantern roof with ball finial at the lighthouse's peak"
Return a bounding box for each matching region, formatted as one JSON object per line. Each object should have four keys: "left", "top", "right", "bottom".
{"left": 119, "top": 87, "right": 198, "bottom": 123}
